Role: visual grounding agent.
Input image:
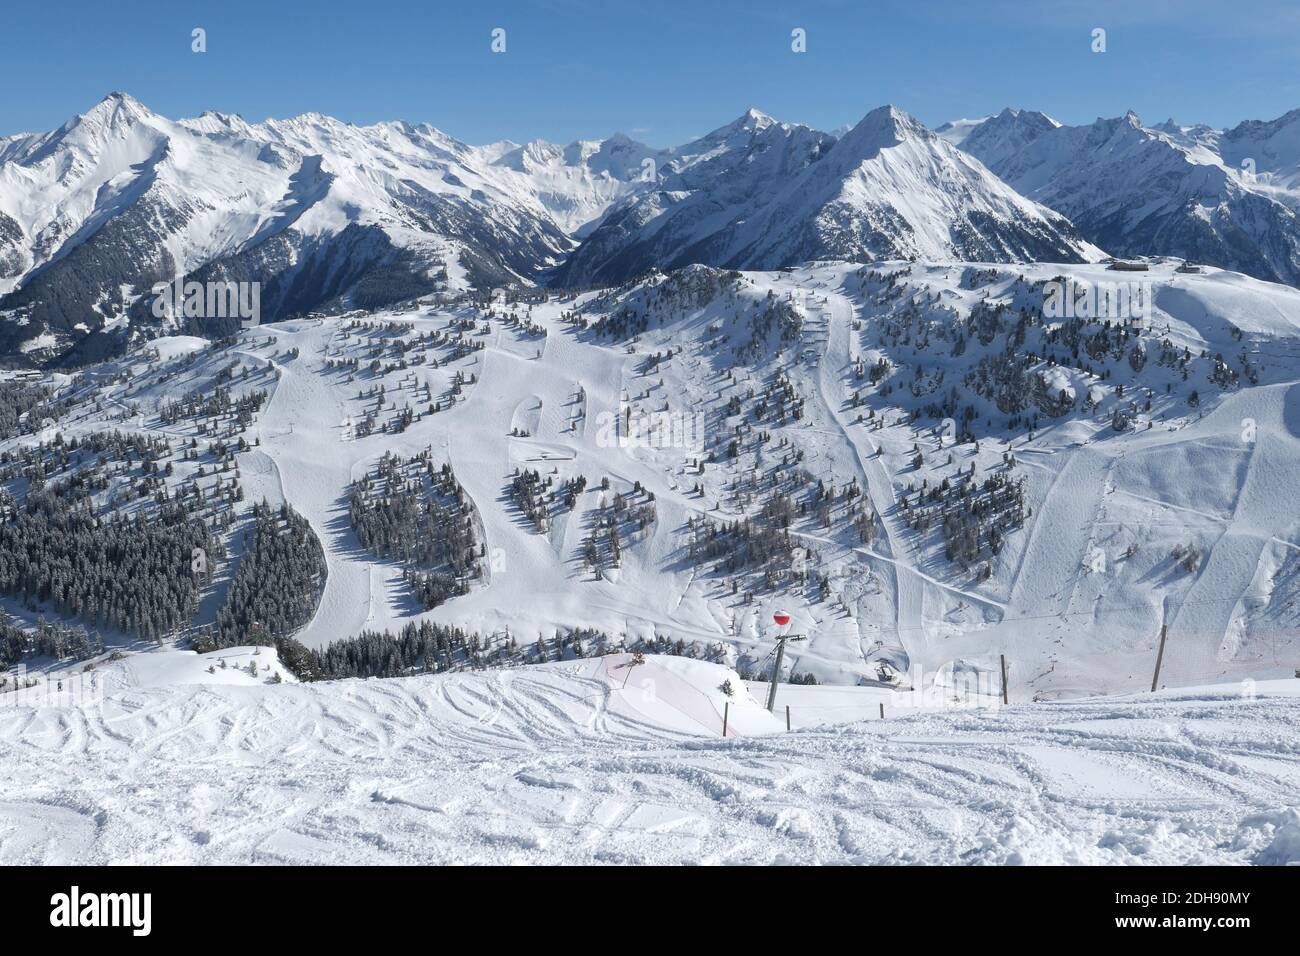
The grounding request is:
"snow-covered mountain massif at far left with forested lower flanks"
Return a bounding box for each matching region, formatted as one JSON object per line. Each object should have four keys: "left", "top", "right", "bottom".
{"left": 0, "top": 94, "right": 660, "bottom": 362}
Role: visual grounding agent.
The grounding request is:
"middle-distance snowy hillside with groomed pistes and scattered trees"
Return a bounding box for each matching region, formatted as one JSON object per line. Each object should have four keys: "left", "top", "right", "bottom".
{"left": 14, "top": 256, "right": 1300, "bottom": 701}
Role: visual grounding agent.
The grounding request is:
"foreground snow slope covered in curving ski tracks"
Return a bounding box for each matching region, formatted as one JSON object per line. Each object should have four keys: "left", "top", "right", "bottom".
{"left": 0, "top": 654, "right": 1300, "bottom": 865}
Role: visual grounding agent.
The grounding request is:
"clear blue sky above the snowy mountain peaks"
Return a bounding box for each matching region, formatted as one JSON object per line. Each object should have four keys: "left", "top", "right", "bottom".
{"left": 0, "top": 0, "right": 1300, "bottom": 146}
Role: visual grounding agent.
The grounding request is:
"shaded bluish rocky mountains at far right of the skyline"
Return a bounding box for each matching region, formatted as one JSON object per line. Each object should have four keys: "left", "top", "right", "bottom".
{"left": 962, "top": 109, "right": 1300, "bottom": 285}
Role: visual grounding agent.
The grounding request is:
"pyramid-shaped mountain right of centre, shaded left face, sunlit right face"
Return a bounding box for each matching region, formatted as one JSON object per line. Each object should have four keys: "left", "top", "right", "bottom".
{"left": 560, "top": 107, "right": 1101, "bottom": 285}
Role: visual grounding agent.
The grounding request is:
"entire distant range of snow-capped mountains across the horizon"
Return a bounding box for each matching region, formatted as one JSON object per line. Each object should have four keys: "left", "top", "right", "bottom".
{"left": 0, "top": 92, "right": 1300, "bottom": 365}
